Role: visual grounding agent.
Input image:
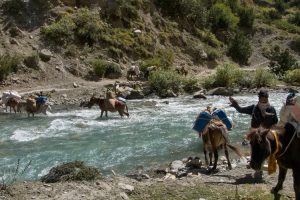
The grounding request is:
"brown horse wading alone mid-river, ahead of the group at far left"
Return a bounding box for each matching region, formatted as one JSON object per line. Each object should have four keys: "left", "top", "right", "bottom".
{"left": 86, "top": 95, "right": 129, "bottom": 117}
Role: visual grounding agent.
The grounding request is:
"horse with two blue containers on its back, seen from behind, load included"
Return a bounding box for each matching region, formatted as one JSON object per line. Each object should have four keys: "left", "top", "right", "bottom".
{"left": 193, "top": 107, "right": 242, "bottom": 170}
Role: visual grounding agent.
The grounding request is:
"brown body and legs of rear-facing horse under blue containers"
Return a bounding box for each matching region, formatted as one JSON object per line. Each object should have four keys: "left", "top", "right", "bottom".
{"left": 202, "top": 120, "right": 242, "bottom": 170}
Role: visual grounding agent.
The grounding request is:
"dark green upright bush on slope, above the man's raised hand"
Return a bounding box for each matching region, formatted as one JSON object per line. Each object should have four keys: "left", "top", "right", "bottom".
{"left": 228, "top": 33, "right": 252, "bottom": 65}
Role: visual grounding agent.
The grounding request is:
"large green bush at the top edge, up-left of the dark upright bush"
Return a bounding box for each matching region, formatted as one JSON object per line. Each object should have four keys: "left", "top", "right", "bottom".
{"left": 209, "top": 3, "right": 239, "bottom": 31}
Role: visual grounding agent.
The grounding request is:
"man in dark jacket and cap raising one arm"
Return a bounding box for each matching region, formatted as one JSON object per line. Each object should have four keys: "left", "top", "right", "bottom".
{"left": 229, "top": 90, "right": 278, "bottom": 129}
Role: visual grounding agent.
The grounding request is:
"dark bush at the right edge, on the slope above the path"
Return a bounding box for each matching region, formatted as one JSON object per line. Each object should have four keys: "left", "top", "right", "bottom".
{"left": 267, "top": 45, "right": 298, "bottom": 77}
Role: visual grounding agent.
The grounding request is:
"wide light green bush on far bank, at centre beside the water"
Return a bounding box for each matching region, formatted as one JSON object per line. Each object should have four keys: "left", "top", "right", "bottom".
{"left": 149, "top": 70, "right": 182, "bottom": 96}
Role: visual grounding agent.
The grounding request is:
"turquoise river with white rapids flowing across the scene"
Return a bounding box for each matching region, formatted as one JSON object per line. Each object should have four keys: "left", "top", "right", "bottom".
{"left": 0, "top": 93, "right": 286, "bottom": 181}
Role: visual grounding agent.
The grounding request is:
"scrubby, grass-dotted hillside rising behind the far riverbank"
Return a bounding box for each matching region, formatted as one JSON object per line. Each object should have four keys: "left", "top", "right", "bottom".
{"left": 0, "top": 0, "right": 300, "bottom": 93}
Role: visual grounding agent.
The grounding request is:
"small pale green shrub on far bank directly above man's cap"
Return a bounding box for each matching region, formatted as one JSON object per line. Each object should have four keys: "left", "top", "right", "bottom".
{"left": 253, "top": 68, "right": 275, "bottom": 88}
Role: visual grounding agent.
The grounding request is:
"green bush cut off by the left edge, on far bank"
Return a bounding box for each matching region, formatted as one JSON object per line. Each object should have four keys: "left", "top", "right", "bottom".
{"left": 0, "top": 55, "right": 20, "bottom": 81}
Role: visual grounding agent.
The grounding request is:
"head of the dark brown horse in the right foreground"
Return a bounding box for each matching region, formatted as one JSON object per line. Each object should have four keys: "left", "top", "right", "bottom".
{"left": 247, "top": 130, "right": 272, "bottom": 170}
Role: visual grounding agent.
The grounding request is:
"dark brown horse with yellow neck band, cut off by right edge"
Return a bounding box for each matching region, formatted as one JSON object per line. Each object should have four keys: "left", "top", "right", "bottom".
{"left": 248, "top": 123, "right": 300, "bottom": 200}
